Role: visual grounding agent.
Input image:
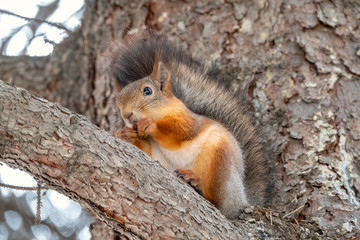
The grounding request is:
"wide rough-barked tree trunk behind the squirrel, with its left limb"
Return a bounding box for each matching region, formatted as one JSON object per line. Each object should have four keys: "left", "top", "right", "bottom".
{"left": 0, "top": 0, "right": 360, "bottom": 238}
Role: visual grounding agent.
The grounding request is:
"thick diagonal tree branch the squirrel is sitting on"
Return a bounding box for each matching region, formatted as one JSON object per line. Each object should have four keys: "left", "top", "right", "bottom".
{"left": 0, "top": 81, "right": 258, "bottom": 239}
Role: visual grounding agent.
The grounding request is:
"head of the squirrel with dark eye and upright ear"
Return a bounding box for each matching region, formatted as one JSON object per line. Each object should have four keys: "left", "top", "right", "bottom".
{"left": 116, "top": 61, "right": 174, "bottom": 128}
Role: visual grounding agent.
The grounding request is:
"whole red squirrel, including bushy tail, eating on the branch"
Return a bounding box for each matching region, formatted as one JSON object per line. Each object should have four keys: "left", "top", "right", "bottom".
{"left": 111, "top": 34, "right": 273, "bottom": 218}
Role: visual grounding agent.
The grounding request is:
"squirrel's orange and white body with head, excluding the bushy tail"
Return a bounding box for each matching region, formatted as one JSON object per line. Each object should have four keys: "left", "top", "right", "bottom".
{"left": 116, "top": 62, "right": 248, "bottom": 218}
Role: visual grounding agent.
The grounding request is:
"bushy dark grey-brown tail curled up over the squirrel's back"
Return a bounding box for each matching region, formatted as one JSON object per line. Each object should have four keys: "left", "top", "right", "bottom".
{"left": 111, "top": 34, "right": 273, "bottom": 206}
